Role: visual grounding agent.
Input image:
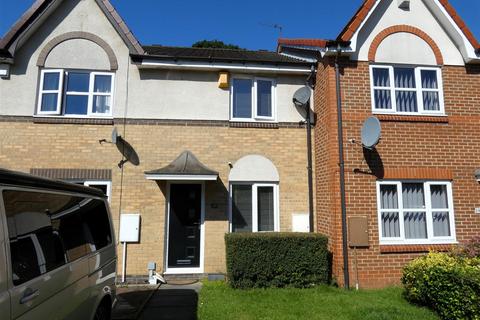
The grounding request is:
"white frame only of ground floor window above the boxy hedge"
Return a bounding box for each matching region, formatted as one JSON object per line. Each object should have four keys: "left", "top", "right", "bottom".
{"left": 229, "top": 182, "right": 280, "bottom": 232}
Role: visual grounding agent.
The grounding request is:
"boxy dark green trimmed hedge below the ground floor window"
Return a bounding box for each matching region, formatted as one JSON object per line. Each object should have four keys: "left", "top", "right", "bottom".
{"left": 225, "top": 233, "right": 331, "bottom": 289}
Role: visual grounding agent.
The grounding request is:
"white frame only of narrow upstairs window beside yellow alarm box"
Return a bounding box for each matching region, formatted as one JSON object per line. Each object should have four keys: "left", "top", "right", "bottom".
{"left": 230, "top": 75, "right": 277, "bottom": 122}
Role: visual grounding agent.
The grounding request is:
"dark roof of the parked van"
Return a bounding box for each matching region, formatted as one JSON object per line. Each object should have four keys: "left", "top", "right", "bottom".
{"left": 0, "top": 169, "right": 106, "bottom": 198}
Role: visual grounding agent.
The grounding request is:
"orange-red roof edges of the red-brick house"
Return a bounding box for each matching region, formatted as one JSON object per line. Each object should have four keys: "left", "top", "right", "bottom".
{"left": 278, "top": 0, "right": 480, "bottom": 50}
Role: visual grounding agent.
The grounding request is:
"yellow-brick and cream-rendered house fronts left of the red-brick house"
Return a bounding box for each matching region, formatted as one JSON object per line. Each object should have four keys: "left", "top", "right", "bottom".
{"left": 0, "top": 0, "right": 311, "bottom": 279}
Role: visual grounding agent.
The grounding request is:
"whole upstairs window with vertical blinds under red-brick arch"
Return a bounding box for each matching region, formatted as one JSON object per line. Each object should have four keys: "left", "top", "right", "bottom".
{"left": 370, "top": 65, "right": 445, "bottom": 115}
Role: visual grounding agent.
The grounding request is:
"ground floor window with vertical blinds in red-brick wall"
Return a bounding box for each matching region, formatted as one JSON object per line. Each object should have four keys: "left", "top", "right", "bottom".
{"left": 377, "top": 181, "right": 455, "bottom": 244}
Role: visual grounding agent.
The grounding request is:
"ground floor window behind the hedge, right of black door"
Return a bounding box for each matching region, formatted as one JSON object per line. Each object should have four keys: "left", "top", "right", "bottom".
{"left": 230, "top": 183, "right": 279, "bottom": 232}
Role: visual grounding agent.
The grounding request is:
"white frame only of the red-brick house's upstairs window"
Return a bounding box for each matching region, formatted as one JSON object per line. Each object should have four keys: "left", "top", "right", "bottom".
{"left": 370, "top": 64, "right": 446, "bottom": 116}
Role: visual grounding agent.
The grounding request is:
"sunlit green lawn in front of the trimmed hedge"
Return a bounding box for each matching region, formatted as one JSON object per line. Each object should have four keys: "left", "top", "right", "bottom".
{"left": 198, "top": 281, "right": 439, "bottom": 320}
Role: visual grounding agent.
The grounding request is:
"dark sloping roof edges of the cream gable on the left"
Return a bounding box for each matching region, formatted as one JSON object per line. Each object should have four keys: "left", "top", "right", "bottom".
{"left": 0, "top": 0, "right": 144, "bottom": 54}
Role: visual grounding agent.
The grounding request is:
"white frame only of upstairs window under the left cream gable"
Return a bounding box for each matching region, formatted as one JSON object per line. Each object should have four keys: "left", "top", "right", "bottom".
{"left": 37, "top": 69, "right": 115, "bottom": 118}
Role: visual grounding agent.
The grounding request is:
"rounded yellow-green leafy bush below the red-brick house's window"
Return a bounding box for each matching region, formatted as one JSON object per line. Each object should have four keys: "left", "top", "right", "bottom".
{"left": 402, "top": 253, "right": 480, "bottom": 320}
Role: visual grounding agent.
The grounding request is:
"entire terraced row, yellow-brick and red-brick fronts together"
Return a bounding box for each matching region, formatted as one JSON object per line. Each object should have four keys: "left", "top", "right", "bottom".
{"left": 0, "top": 0, "right": 480, "bottom": 287}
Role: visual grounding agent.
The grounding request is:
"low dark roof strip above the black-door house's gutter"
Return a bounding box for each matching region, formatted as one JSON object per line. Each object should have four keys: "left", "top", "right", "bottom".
{"left": 138, "top": 45, "right": 309, "bottom": 65}
